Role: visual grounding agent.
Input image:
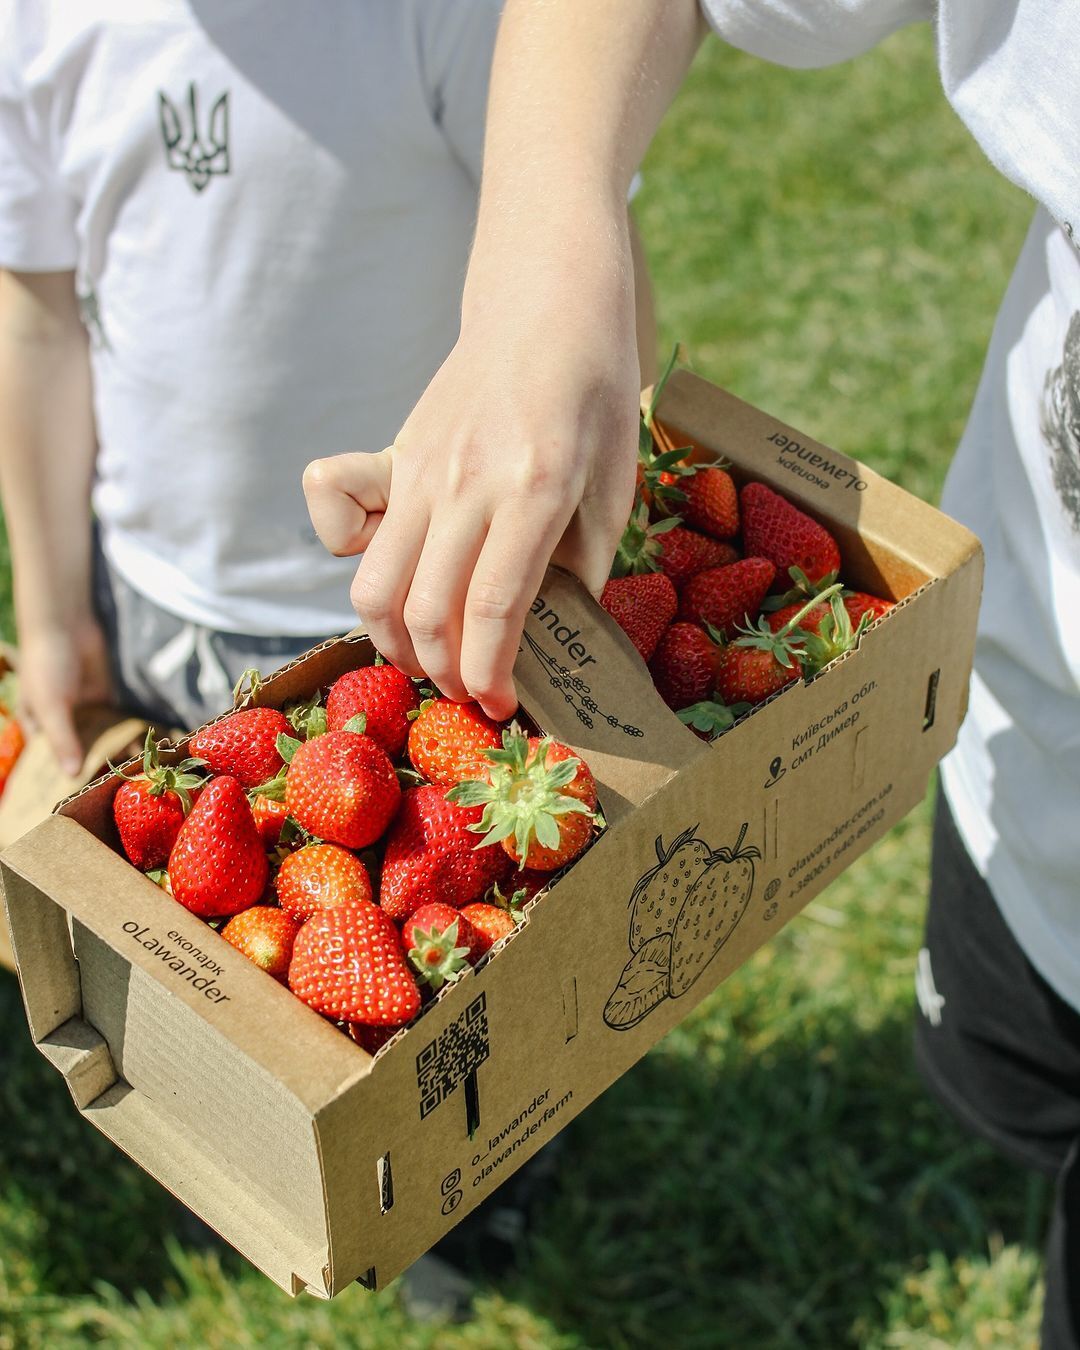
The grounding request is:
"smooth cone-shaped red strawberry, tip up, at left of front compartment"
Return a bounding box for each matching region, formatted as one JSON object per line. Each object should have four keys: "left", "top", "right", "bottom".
{"left": 169, "top": 775, "right": 270, "bottom": 918}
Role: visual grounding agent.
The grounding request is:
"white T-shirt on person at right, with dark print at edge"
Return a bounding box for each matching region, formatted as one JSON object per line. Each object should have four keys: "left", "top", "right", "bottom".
{"left": 702, "top": 0, "right": 1080, "bottom": 1008}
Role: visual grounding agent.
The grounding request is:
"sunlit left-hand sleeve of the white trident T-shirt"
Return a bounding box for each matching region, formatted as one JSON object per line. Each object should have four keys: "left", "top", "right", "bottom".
{"left": 0, "top": 7, "right": 77, "bottom": 271}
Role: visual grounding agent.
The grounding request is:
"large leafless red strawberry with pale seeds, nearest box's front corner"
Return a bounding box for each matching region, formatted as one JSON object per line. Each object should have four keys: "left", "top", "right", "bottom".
{"left": 289, "top": 907, "right": 420, "bottom": 1026}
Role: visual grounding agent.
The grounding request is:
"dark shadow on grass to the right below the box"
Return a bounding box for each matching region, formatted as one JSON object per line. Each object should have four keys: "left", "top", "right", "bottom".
{"left": 505, "top": 999, "right": 1048, "bottom": 1350}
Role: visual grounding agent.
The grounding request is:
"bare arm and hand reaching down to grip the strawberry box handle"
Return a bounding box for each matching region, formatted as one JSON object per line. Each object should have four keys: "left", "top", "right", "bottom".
{"left": 304, "top": 0, "right": 702, "bottom": 717}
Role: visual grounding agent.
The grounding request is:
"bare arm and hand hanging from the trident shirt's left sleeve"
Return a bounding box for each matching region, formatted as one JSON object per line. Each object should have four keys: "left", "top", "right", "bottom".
{"left": 0, "top": 271, "right": 108, "bottom": 772}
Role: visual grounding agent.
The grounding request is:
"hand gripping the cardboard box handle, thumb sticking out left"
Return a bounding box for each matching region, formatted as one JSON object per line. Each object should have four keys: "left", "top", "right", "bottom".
{"left": 304, "top": 266, "right": 639, "bottom": 718}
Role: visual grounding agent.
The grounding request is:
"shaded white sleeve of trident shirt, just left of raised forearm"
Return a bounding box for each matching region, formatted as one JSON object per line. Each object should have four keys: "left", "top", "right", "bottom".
{"left": 420, "top": 0, "right": 502, "bottom": 184}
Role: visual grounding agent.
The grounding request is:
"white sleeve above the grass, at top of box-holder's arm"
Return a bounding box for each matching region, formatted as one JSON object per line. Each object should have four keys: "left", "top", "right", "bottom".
{"left": 701, "top": 0, "right": 936, "bottom": 68}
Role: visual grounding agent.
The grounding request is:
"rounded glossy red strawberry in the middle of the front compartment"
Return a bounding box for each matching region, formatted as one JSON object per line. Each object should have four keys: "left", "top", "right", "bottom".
{"left": 279, "top": 730, "right": 401, "bottom": 849}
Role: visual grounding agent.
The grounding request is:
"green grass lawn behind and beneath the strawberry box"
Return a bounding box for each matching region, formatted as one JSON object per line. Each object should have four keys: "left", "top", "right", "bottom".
{"left": 0, "top": 23, "right": 1046, "bottom": 1350}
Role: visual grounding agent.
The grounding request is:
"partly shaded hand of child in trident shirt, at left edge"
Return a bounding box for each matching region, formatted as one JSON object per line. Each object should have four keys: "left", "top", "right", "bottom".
{"left": 19, "top": 617, "right": 112, "bottom": 775}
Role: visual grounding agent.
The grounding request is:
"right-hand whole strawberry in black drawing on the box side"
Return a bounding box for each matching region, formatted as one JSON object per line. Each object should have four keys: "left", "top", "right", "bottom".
{"left": 670, "top": 824, "right": 761, "bottom": 999}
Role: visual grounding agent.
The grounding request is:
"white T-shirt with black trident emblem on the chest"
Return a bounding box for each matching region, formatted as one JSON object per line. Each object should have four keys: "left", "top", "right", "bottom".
{"left": 0, "top": 0, "right": 501, "bottom": 635}
